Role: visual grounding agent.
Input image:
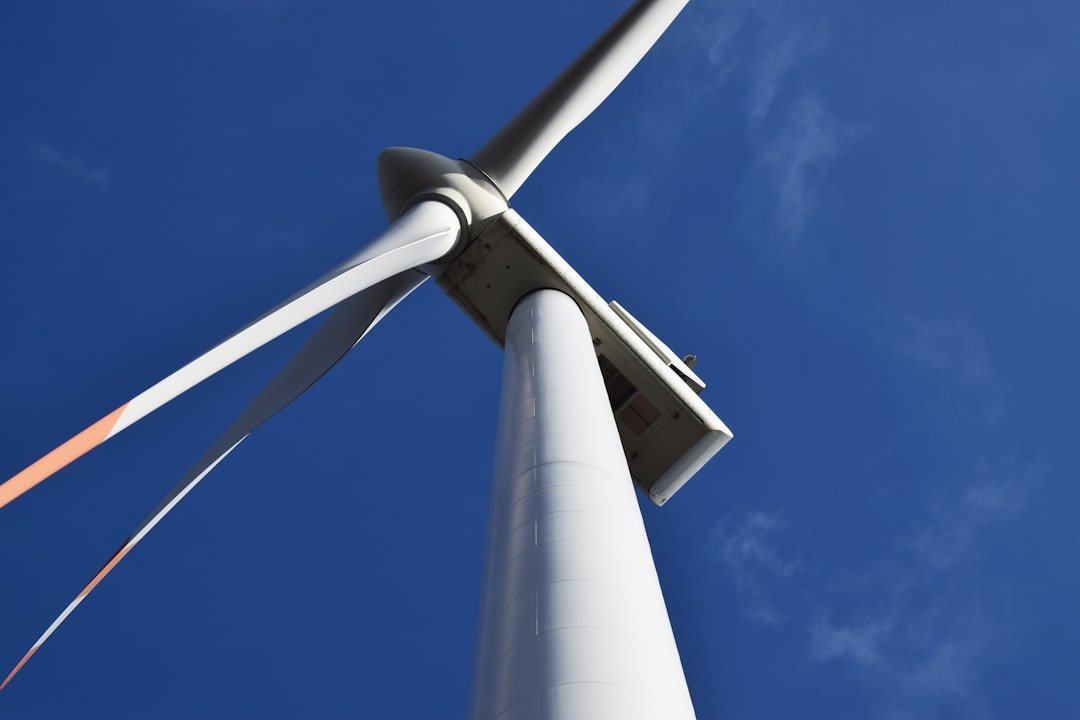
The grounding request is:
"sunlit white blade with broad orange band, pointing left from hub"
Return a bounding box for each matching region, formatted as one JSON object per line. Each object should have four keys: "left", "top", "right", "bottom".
{"left": 0, "top": 202, "right": 461, "bottom": 507}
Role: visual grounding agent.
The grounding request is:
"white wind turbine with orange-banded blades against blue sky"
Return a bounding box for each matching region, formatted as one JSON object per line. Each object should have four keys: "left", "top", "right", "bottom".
{"left": 0, "top": 0, "right": 730, "bottom": 718}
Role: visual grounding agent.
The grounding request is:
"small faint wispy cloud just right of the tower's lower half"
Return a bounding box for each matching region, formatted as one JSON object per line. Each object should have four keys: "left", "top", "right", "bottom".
{"left": 708, "top": 513, "right": 799, "bottom": 625}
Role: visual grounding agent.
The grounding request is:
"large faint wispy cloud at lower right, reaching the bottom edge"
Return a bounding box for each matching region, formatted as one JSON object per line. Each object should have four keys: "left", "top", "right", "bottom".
{"left": 808, "top": 465, "right": 1037, "bottom": 719}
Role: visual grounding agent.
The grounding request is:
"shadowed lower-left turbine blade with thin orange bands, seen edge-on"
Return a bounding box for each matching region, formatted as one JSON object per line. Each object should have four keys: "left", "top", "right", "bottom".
{"left": 0, "top": 270, "right": 428, "bottom": 690}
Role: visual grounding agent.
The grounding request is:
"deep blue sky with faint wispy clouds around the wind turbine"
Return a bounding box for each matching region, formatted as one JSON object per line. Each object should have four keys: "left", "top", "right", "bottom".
{"left": 0, "top": 0, "right": 1080, "bottom": 720}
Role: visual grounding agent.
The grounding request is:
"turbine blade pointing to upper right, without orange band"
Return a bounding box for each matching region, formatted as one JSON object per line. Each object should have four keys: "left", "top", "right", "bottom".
{"left": 469, "top": 0, "right": 688, "bottom": 200}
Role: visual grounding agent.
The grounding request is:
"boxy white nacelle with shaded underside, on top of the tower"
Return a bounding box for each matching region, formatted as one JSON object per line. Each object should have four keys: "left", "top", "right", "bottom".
{"left": 436, "top": 207, "right": 731, "bottom": 505}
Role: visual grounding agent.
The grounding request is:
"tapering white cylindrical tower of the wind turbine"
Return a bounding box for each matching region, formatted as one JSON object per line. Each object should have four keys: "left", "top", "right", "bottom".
{"left": 470, "top": 289, "right": 693, "bottom": 720}
